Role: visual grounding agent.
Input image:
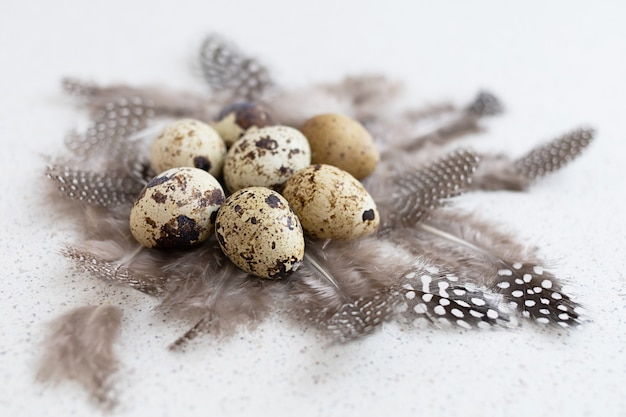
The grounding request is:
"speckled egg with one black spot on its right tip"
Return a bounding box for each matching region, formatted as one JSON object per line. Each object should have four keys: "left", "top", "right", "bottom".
{"left": 283, "top": 164, "right": 380, "bottom": 240}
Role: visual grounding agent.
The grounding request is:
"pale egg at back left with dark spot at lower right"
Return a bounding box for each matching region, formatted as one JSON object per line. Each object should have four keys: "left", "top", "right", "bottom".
{"left": 150, "top": 119, "right": 226, "bottom": 177}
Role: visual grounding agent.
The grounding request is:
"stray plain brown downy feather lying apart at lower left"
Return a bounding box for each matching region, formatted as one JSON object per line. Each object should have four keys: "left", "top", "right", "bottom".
{"left": 37, "top": 306, "right": 122, "bottom": 408}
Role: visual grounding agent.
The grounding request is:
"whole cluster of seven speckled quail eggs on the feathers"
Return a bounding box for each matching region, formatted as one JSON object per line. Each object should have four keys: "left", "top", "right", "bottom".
{"left": 130, "top": 102, "right": 379, "bottom": 279}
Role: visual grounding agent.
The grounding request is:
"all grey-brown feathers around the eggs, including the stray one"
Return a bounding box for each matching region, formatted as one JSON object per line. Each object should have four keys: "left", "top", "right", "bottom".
{"left": 39, "top": 35, "right": 594, "bottom": 406}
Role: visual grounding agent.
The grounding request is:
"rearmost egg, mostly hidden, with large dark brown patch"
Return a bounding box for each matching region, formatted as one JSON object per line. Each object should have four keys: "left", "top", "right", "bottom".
{"left": 213, "top": 101, "right": 274, "bottom": 147}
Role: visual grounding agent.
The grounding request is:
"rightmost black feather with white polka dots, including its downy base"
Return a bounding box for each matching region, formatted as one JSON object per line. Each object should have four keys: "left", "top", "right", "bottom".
{"left": 420, "top": 213, "right": 580, "bottom": 327}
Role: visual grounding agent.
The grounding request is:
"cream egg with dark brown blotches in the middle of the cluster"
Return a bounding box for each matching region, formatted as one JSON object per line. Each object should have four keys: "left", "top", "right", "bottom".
{"left": 224, "top": 126, "right": 311, "bottom": 192}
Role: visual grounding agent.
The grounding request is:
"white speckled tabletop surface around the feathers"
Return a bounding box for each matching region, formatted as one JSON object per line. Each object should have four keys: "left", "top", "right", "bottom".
{"left": 0, "top": 0, "right": 626, "bottom": 416}
